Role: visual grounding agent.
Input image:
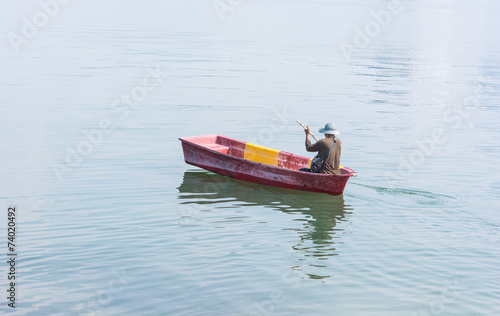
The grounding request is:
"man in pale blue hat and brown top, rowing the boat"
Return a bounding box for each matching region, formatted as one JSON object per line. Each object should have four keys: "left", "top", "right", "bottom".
{"left": 300, "top": 123, "right": 342, "bottom": 174}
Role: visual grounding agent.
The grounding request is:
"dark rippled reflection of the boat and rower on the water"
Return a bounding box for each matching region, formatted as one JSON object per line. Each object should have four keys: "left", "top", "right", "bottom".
{"left": 178, "top": 170, "right": 352, "bottom": 279}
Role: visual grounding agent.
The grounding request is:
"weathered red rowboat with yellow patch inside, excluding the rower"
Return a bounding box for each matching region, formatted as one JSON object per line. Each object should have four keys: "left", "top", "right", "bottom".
{"left": 179, "top": 135, "right": 357, "bottom": 195}
